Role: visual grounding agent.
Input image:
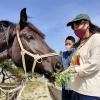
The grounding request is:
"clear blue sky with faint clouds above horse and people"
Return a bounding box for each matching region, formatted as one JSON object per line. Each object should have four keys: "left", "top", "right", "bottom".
{"left": 0, "top": 0, "right": 100, "bottom": 53}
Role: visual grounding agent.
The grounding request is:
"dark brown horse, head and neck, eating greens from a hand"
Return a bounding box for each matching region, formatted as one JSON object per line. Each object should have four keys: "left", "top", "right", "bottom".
{"left": 0, "top": 8, "right": 62, "bottom": 81}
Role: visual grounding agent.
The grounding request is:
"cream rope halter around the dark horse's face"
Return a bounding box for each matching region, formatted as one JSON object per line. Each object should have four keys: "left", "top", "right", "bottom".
{"left": 16, "top": 30, "right": 58, "bottom": 77}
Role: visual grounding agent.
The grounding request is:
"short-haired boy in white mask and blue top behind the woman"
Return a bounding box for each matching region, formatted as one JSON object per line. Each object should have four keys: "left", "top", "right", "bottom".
{"left": 61, "top": 36, "right": 75, "bottom": 100}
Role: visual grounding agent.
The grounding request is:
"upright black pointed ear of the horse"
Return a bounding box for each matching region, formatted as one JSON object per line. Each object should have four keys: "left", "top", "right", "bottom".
{"left": 19, "top": 8, "right": 27, "bottom": 30}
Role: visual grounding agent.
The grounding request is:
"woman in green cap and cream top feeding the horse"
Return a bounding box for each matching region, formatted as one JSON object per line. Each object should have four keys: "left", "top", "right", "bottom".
{"left": 63, "top": 14, "right": 100, "bottom": 100}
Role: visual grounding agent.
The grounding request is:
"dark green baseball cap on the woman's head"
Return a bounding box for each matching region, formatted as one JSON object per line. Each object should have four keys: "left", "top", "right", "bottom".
{"left": 67, "top": 14, "right": 90, "bottom": 26}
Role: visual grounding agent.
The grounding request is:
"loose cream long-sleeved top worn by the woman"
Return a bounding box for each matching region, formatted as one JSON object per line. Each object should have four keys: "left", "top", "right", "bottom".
{"left": 70, "top": 33, "right": 100, "bottom": 97}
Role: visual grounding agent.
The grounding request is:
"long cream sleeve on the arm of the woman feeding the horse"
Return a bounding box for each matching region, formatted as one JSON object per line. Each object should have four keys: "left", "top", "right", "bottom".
{"left": 75, "top": 34, "right": 100, "bottom": 77}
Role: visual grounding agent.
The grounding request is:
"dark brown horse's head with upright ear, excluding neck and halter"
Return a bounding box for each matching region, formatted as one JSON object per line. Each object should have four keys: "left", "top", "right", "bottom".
{"left": 11, "top": 8, "right": 62, "bottom": 80}
